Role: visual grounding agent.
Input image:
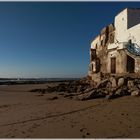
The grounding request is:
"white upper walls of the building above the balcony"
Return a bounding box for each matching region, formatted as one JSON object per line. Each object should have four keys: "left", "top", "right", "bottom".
{"left": 115, "top": 9, "right": 140, "bottom": 45}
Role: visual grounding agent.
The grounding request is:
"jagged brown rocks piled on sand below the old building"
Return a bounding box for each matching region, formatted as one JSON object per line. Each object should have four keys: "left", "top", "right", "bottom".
{"left": 31, "top": 76, "right": 140, "bottom": 101}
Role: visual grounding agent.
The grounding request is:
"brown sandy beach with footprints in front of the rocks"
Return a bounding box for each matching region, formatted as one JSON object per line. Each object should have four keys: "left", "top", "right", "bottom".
{"left": 0, "top": 84, "right": 140, "bottom": 138}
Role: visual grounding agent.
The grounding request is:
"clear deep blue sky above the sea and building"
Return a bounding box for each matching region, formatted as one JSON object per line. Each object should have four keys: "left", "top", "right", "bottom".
{"left": 0, "top": 2, "right": 140, "bottom": 78}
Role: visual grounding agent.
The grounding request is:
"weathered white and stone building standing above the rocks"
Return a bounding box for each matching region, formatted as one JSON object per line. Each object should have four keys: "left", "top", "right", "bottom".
{"left": 88, "top": 8, "right": 140, "bottom": 80}
